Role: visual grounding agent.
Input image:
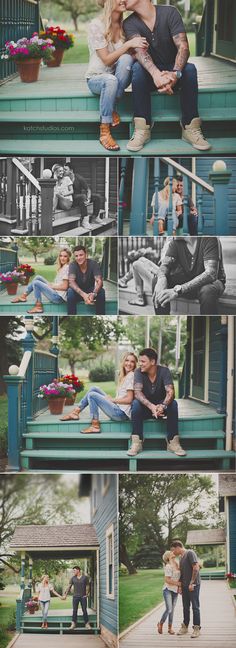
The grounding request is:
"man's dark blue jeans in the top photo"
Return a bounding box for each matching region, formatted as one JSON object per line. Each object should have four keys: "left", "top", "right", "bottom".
{"left": 132, "top": 62, "right": 199, "bottom": 126}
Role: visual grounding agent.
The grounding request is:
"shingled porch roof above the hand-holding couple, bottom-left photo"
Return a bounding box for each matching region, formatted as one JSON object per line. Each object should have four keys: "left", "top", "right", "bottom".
{"left": 10, "top": 524, "right": 99, "bottom": 550}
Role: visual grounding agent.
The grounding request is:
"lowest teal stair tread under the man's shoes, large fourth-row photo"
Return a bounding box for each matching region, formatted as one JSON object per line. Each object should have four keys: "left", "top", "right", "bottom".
{"left": 20, "top": 449, "right": 236, "bottom": 460}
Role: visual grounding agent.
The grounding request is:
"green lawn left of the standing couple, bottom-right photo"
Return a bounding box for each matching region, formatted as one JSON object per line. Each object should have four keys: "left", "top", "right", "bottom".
{"left": 119, "top": 569, "right": 164, "bottom": 632}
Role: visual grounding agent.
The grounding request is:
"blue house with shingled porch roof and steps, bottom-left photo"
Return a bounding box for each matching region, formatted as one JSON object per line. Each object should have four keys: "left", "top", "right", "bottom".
{"left": 10, "top": 474, "right": 118, "bottom": 648}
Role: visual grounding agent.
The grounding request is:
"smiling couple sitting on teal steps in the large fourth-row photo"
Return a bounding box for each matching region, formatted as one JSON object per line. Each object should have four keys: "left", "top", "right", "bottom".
{"left": 61, "top": 348, "right": 186, "bottom": 457}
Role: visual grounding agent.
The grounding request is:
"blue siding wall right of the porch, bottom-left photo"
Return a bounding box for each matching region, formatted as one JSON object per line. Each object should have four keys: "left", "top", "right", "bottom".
{"left": 91, "top": 475, "right": 119, "bottom": 635}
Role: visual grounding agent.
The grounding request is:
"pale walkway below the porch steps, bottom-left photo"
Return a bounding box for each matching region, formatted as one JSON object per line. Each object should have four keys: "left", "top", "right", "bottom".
{"left": 9, "top": 633, "right": 105, "bottom": 648}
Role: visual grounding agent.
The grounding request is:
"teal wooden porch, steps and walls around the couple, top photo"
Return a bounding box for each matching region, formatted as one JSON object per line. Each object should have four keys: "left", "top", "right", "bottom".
{"left": 0, "top": 0, "right": 236, "bottom": 157}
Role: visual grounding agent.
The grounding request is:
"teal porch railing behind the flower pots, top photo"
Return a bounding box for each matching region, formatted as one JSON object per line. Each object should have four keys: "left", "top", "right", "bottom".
{"left": 0, "top": 0, "right": 40, "bottom": 84}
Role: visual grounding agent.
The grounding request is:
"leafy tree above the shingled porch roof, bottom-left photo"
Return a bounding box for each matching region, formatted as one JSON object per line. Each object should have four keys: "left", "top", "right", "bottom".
{"left": 0, "top": 475, "right": 78, "bottom": 573}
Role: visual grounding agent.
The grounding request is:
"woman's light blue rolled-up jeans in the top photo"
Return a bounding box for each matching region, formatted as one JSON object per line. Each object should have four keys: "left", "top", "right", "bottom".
{"left": 87, "top": 54, "right": 134, "bottom": 124}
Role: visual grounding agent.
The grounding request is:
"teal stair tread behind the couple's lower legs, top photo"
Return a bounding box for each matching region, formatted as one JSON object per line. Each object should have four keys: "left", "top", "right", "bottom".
{"left": 0, "top": 106, "right": 236, "bottom": 123}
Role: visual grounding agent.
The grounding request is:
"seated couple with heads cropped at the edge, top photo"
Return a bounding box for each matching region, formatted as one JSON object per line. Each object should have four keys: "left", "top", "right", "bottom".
{"left": 86, "top": 0, "right": 211, "bottom": 152}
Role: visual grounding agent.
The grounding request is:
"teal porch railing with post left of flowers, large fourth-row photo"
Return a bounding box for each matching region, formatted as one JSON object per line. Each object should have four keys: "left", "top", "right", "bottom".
{"left": 4, "top": 320, "right": 58, "bottom": 470}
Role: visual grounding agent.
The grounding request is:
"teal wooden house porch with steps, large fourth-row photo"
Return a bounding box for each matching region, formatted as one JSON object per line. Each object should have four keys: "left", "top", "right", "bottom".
{"left": 4, "top": 316, "right": 236, "bottom": 473}
